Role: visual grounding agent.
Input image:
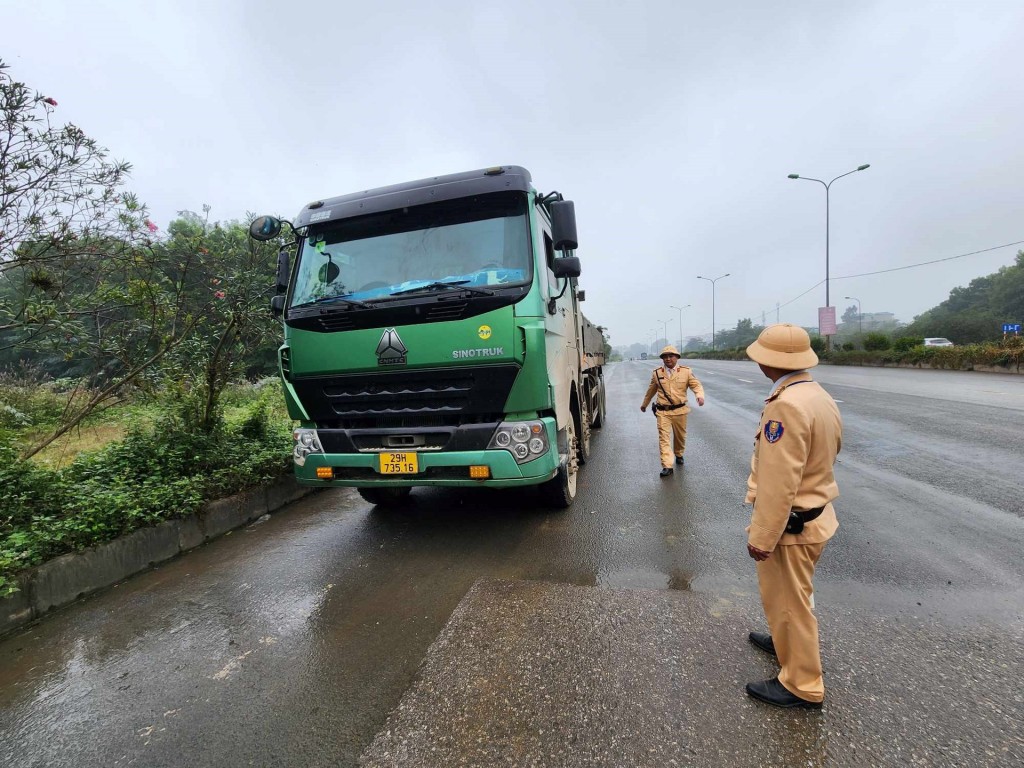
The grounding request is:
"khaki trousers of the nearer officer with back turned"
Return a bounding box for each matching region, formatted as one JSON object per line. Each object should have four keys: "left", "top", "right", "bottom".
{"left": 757, "top": 542, "right": 825, "bottom": 701}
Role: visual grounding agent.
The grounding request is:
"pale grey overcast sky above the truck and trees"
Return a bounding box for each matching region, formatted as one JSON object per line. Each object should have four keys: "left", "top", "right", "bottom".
{"left": 0, "top": 0, "right": 1024, "bottom": 345}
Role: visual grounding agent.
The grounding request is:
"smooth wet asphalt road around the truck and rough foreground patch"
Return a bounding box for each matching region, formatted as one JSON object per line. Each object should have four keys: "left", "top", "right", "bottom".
{"left": 0, "top": 361, "right": 1024, "bottom": 768}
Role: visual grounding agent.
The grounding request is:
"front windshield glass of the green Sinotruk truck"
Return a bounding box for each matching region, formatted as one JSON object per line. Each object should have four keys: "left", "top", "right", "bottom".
{"left": 291, "top": 193, "right": 532, "bottom": 308}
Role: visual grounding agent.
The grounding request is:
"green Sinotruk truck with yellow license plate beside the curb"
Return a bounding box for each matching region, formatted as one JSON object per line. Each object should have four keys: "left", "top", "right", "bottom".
{"left": 250, "top": 166, "right": 605, "bottom": 507}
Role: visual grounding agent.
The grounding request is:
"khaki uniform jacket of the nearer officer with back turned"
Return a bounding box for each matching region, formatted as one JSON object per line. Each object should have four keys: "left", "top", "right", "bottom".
{"left": 745, "top": 372, "right": 843, "bottom": 552}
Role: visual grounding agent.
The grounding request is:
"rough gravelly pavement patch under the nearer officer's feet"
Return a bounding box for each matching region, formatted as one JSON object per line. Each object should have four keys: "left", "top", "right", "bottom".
{"left": 360, "top": 581, "right": 1024, "bottom": 768}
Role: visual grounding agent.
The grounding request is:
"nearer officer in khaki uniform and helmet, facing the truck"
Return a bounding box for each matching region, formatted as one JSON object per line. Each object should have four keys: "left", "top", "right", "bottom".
{"left": 745, "top": 323, "right": 843, "bottom": 709}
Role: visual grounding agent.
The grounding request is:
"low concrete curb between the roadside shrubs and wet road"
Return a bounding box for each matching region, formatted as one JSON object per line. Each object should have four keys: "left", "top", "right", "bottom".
{"left": 0, "top": 475, "right": 319, "bottom": 636}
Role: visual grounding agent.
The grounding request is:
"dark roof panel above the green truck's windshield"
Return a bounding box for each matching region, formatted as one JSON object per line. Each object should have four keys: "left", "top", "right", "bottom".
{"left": 294, "top": 165, "right": 532, "bottom": 228}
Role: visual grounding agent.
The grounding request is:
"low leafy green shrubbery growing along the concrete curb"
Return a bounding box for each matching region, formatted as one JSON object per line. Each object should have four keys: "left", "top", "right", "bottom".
{"left": 0, "top": 387, "right": 292, "bottom": 596}
